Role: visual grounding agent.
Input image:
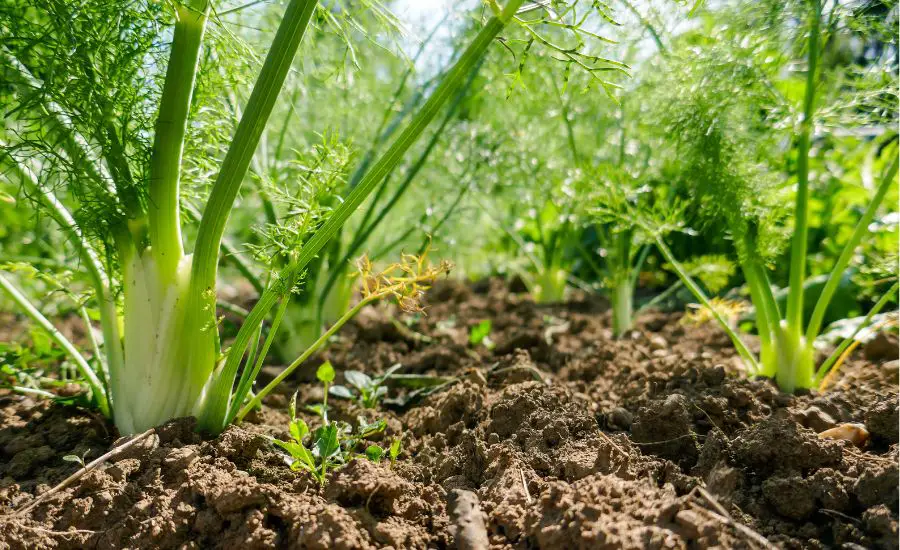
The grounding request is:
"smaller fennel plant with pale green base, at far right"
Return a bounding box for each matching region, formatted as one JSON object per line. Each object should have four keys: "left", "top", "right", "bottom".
{"left": 648, "top": 0, "right": 898, "bottom": 392}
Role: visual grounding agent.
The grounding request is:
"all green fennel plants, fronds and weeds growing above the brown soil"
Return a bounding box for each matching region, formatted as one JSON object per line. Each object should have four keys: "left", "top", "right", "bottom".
{"left": 0, "top": 0, "right": 900, "bottom": 444}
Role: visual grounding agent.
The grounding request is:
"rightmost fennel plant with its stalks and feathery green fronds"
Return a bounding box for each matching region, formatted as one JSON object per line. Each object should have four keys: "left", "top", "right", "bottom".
{"left": 640, "top": 0, "right": 897, "bottom": 391}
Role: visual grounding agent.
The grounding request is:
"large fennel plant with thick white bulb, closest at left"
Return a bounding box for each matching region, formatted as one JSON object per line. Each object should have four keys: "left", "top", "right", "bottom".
{"left": 0, "top": 0, "right": 523, "bottom": 433}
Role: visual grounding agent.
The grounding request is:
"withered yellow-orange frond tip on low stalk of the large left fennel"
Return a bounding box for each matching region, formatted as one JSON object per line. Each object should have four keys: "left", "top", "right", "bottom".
{"left": 356, "top": 249, "right": 453, "bottom": 313}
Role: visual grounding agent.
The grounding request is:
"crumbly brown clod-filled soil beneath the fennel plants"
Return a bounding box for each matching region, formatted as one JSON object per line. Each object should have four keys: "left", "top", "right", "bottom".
{"left": 0, "top": 281, "right": 898, "bottom": 550}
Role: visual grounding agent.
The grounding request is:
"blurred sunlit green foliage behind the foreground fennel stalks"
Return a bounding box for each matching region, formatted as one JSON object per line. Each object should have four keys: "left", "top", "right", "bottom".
{"left": 0, "top": 0, "right": 900, "bottom": 356}
